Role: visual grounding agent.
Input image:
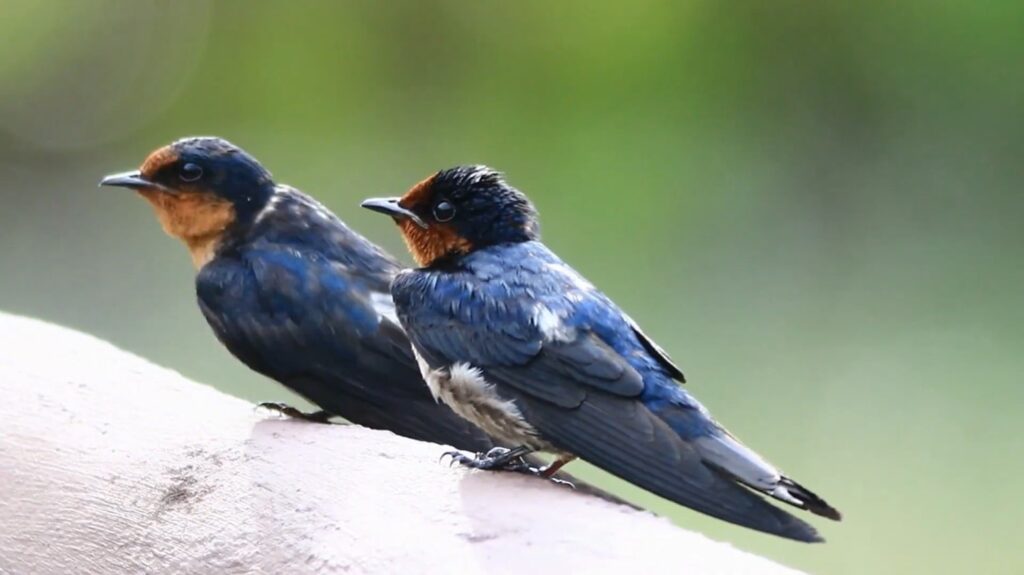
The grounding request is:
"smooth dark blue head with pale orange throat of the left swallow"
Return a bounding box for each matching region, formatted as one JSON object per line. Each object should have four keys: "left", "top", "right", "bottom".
{"left": 99, "top": 137, "right": 274, "bottom": 266}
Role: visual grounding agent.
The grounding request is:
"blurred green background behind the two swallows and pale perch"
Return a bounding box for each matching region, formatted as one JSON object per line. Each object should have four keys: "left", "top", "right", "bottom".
{"left": 0, "top": 0, "right": 1024, "bottom": 574}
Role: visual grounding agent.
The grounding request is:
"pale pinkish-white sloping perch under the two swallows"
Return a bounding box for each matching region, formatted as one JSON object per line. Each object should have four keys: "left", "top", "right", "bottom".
{"left": 0, "top": 314, "right": 795, "bottom": 575}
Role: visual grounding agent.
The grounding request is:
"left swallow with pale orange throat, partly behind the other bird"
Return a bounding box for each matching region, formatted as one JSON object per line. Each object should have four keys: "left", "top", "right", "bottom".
{"left": 100, "top": 137, "right": 628, "bottom": 504}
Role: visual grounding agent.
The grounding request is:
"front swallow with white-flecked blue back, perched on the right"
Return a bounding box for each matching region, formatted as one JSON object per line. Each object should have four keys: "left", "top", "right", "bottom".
{"left": 362, "top": 166, "right": 840, "bottom": 542}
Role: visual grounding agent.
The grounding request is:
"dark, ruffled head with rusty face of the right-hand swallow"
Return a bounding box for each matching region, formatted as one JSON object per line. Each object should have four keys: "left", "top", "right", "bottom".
{"left": 362, "top": 166, "right": 540, "bottom": 266}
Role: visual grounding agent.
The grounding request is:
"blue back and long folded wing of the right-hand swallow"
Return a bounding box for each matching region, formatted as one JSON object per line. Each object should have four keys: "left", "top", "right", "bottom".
{"left": 391, "top": 241, "right": 820, "bottom": 541}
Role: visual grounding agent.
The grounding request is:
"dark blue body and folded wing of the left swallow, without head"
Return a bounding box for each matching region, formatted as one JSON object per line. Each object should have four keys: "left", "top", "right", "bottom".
{"left": 196, "top": 189, "right": 494, "bottom": 451}
